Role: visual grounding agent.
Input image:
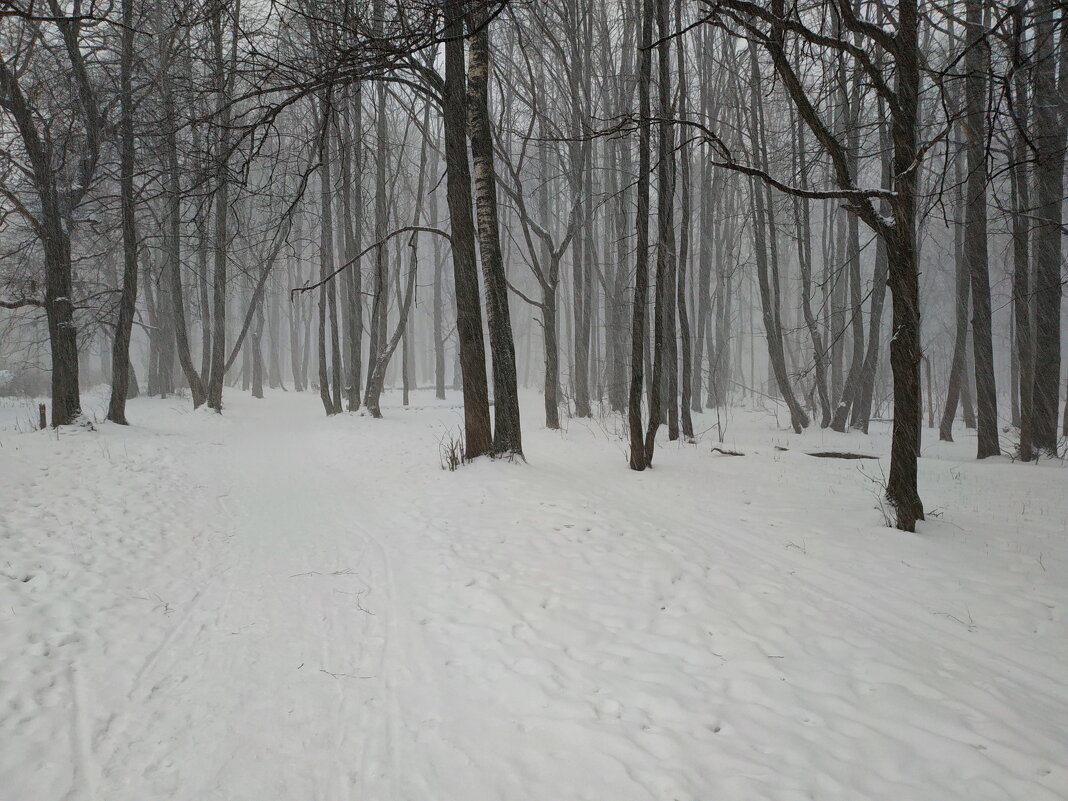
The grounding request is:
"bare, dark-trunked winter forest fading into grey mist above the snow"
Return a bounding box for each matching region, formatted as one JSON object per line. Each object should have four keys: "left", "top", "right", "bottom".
{"left": 0, "top": 0, "right": 1068, "bottom": 531}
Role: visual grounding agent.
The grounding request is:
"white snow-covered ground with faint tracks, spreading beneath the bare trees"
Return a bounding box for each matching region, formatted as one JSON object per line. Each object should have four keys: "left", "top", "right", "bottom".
{"left": 0, "top": 392, "right": 1068, "bottom": 801}
